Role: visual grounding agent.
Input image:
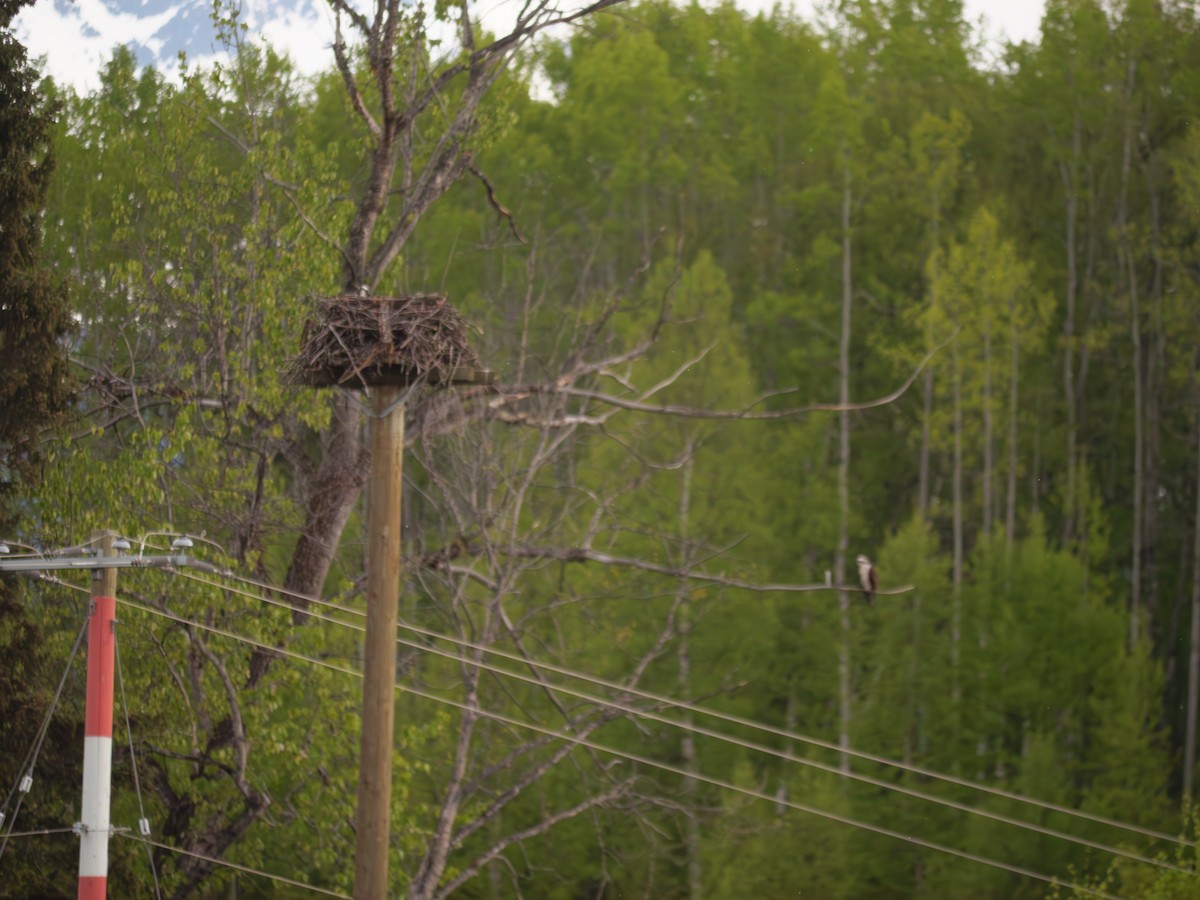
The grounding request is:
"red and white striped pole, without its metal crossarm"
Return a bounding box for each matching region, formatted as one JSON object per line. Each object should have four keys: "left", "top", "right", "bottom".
{"left": 77, "top": 534, "right": 116, "bottom": 900}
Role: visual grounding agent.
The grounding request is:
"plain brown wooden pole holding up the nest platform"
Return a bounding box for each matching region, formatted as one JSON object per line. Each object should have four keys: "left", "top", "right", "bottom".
{"left": 354, "top": 384, "right": 404, "bottom": 900}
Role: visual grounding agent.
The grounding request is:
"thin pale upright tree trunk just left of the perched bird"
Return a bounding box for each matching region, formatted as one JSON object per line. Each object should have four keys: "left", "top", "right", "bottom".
{"left": 834, "top": 157, "right": 853, "bottom": 772}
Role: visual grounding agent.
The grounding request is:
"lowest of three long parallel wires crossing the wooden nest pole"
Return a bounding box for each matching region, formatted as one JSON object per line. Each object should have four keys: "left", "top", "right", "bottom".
{"left": 116, "top": 599, "right": 1122, "bottom": 900}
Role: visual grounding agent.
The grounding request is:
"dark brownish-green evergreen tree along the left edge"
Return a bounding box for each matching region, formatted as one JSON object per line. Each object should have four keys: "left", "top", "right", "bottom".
{"left": 0, "top": 0, "right": 75, "bottom": 896}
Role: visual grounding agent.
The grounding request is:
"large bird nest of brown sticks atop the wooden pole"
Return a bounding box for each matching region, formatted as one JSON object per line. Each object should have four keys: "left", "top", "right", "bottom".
{"left": 289, "top": 294, "right": 479, "bottom": 386}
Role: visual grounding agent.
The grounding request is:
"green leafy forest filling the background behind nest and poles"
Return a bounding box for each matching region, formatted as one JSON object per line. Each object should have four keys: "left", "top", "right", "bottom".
{"left": 0, "top": 0, "right": 1200, "bottom": 898}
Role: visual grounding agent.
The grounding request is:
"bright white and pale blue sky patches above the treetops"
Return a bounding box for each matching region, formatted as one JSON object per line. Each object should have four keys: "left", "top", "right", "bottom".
{"left": 14, "top": 0, "right": 1045, "bottom": 92}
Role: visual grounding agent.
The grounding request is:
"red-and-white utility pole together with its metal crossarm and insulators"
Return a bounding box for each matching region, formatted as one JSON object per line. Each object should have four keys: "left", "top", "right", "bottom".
{"left": 0, "top": 532, "right": 194, "bottom": 900}
